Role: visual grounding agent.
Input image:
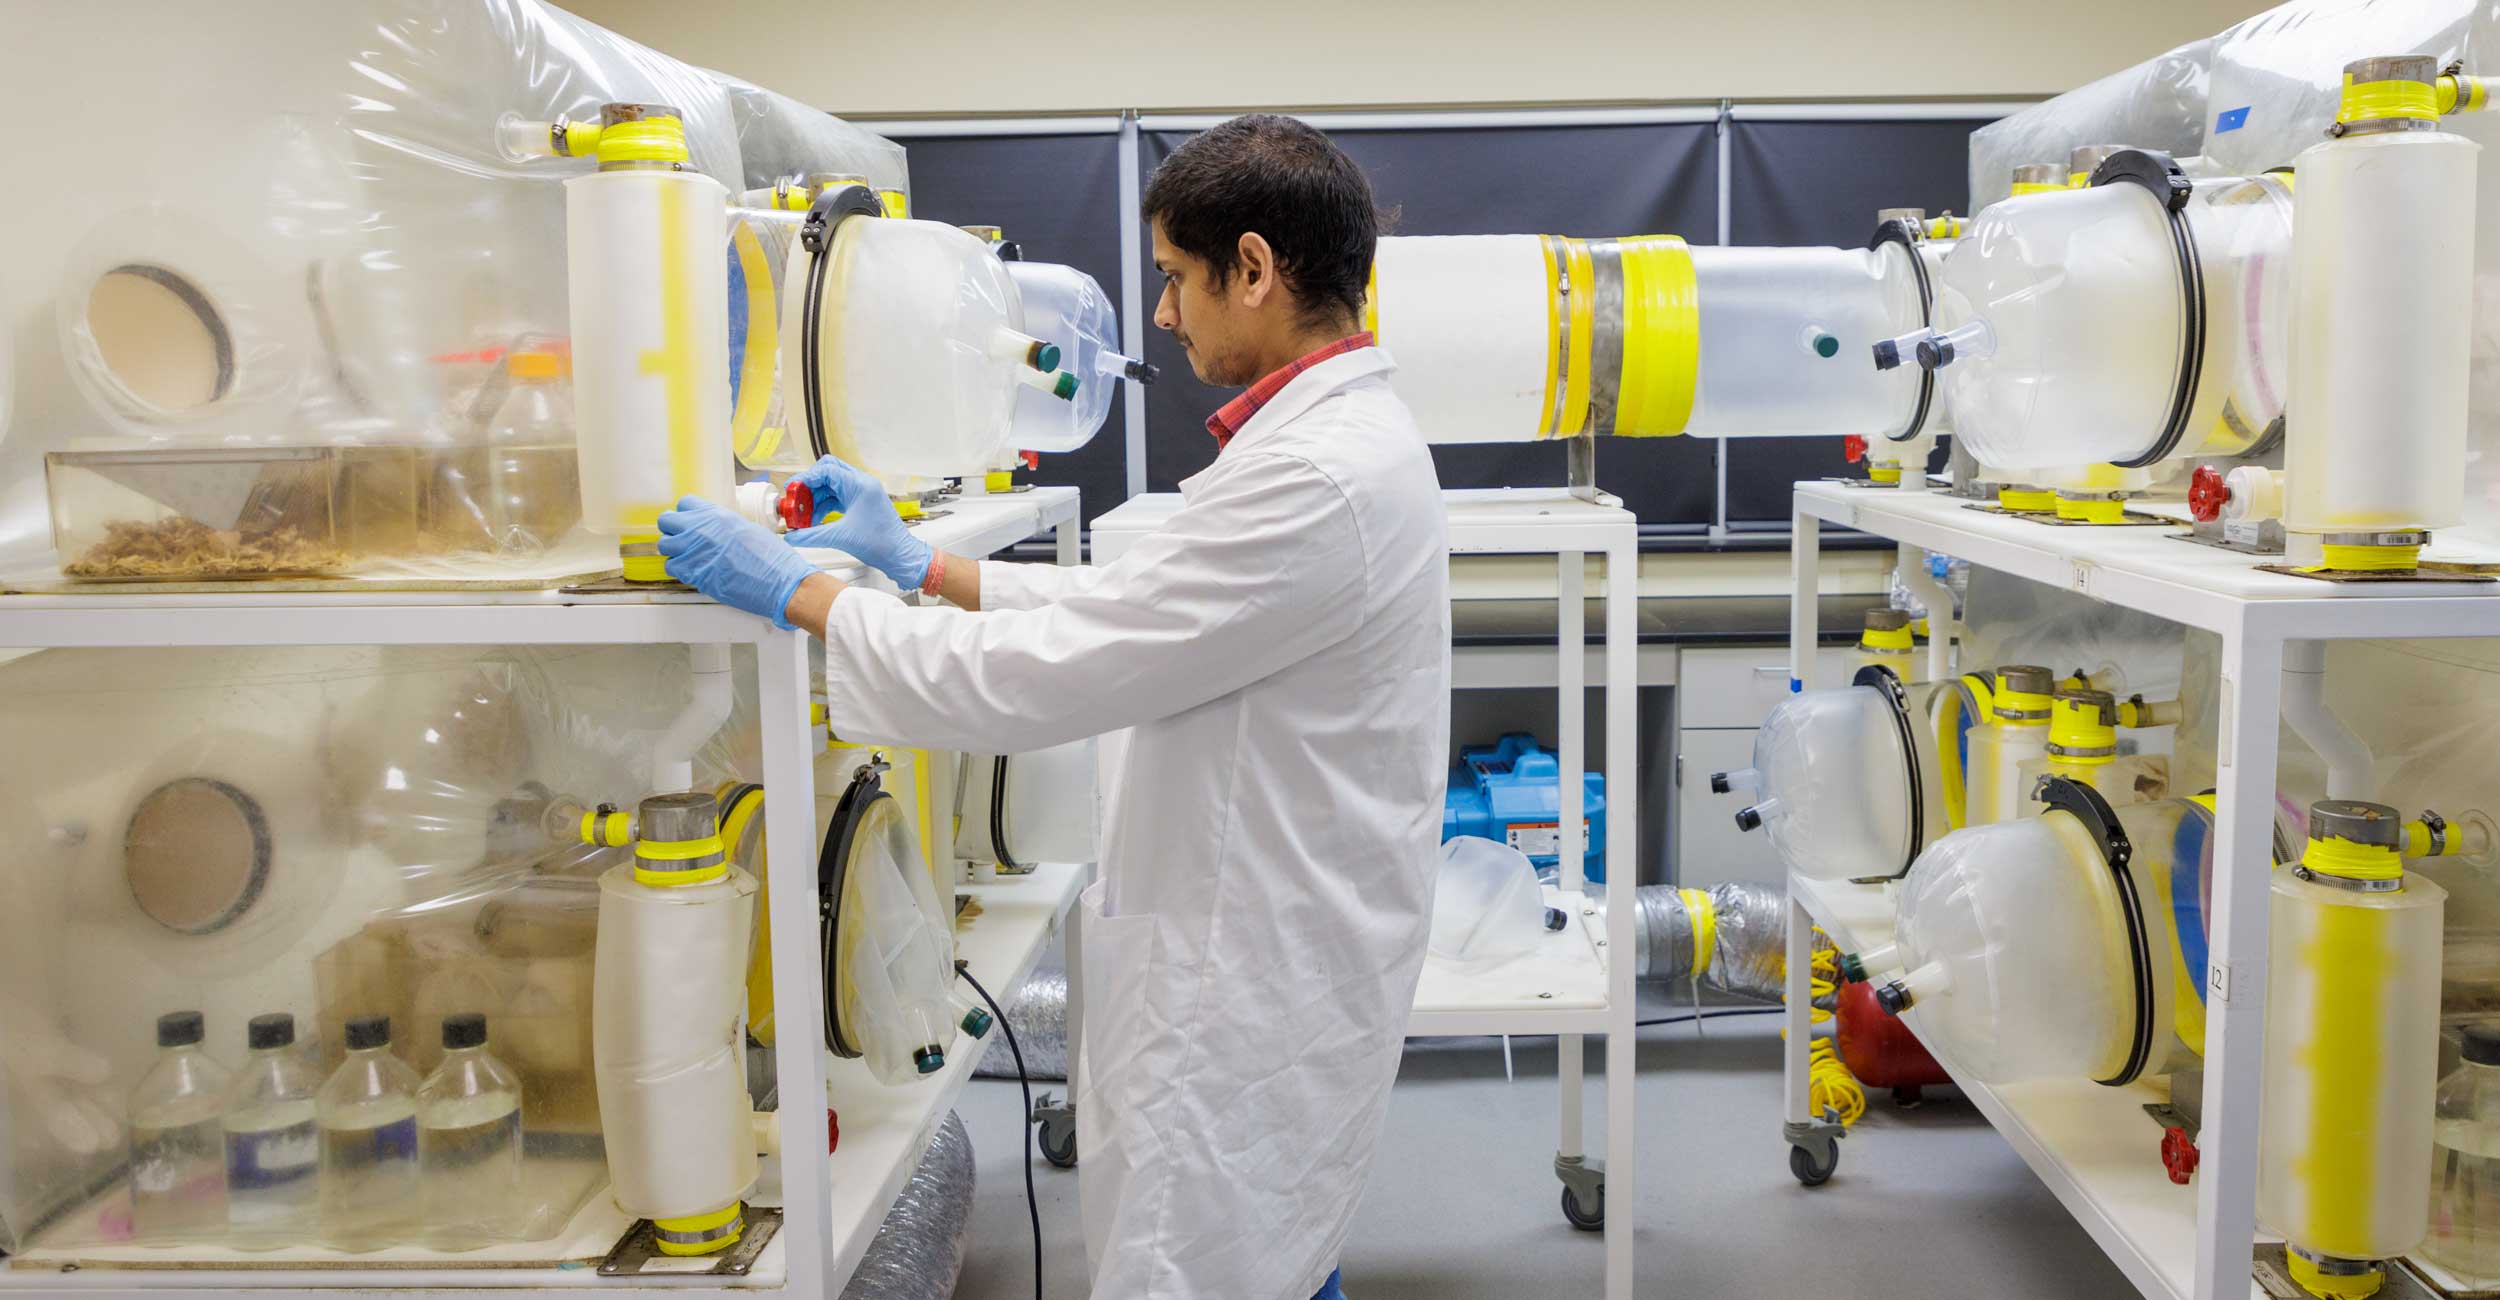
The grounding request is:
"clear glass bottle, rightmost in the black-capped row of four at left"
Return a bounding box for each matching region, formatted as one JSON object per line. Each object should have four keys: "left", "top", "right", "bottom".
{"left": 418, "top": 1013, "right": 528, "bottom": 1250}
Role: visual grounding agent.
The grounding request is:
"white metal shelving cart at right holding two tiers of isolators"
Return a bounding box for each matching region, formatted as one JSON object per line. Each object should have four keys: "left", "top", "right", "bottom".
{"left": 1785, "top": 483, "right": 2500, "bottom": 1300}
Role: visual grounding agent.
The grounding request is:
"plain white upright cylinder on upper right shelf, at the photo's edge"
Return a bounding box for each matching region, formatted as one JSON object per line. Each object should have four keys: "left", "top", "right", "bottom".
{"left": 2283, "top": 130, "right": 2483, "bottom": 533}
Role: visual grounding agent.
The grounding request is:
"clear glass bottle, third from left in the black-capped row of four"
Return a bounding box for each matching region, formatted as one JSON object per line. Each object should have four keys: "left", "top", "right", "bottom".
{"left": 318, "top": 1015, "right": 418, "bottom": 1250}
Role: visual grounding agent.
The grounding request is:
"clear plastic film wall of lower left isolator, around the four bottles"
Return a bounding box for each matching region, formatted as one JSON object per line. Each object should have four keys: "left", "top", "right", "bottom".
{"left": 0, "top": 648, "right": 740, "bottom": 1253}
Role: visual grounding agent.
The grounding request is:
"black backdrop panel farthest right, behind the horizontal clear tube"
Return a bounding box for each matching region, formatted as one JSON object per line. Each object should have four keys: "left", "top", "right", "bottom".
{"left": 1720, "top": 118, "right": 1990, "bottom": 523}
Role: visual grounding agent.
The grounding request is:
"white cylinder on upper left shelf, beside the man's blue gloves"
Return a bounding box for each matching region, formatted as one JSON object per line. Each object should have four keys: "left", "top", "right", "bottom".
{"left": 565, "top": 170, "right": 733, "bottom": 535}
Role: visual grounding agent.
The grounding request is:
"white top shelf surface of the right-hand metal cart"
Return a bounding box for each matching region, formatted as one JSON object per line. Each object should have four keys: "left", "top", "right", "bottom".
{"left": 1795, "top": 483, "right": 2500, "bottom": 638}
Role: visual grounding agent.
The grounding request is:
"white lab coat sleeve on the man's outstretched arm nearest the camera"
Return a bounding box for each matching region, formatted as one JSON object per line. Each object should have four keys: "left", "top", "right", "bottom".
{"left": 825, "top": 455, "right": 1365, "bottom": 753}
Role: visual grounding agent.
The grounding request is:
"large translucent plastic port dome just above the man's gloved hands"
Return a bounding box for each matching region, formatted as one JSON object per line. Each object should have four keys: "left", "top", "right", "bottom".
{"left": 783, "top": 218, "right": 1033, "bottom": 488}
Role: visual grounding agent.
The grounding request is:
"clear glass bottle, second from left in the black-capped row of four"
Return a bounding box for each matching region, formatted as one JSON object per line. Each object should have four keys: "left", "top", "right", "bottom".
{"left": 225, "top": 1013, "right": 320, "bottom": 1250}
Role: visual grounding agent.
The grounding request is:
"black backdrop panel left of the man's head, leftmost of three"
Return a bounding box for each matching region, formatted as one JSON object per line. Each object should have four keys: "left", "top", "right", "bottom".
{"left": 905, "top": 133, "right": 1128, "bottom": 523}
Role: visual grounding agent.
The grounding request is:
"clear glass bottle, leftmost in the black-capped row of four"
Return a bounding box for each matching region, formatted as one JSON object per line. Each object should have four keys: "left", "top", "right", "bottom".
{"left": 130, "top": 1010, "right": 235, "bottom": 1243}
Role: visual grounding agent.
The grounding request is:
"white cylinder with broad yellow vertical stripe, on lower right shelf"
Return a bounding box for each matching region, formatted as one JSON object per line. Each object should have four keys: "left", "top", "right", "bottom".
{"left": 2258, "top": 870, "right": 2448, "bottom": 1260}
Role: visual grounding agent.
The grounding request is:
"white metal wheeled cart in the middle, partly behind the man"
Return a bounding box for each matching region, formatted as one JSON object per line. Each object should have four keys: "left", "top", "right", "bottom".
{"left": 1095, "top": 488, "right": 1640, "bottom": 1300}
